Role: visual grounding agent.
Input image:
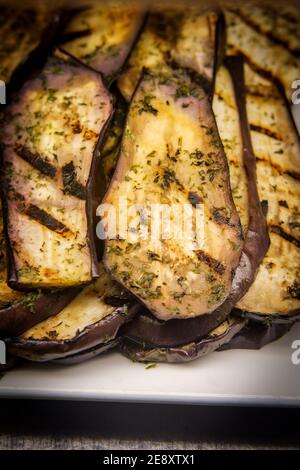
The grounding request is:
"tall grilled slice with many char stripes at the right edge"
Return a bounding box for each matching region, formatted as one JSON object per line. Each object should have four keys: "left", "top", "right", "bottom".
{"left": 237, "top": 67, "right": 300, "bottom": 322}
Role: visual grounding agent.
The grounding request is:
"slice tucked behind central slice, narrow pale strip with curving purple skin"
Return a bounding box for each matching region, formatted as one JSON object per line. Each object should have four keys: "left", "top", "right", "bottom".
{"left": 122, "top": 57, "right": 269, "bottom": 358}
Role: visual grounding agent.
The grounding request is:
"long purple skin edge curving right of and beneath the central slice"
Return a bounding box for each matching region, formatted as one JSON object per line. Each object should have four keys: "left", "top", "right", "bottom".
{"left": 121, "top": 57, "right": 269, "bottom": 347}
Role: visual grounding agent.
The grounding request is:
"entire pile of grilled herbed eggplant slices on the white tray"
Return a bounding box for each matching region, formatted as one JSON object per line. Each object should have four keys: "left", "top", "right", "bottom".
{"left": 0, "top": 4, "right": 300, "bottom": 370}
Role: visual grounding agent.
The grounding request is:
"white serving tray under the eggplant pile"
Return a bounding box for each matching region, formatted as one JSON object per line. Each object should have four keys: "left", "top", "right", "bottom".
{"left": 0, "top": 323, "right": 300, "bottom": 406}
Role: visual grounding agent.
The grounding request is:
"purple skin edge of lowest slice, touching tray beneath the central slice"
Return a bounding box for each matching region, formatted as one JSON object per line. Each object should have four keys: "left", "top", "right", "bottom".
{"left": 120, "top": 319, "right": 246, "bottom": 363}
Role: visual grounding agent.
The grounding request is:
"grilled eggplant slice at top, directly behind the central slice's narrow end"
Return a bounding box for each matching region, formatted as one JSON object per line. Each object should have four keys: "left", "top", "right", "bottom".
{"left": 118, "top": 10, "right": 225, "bottom": 101}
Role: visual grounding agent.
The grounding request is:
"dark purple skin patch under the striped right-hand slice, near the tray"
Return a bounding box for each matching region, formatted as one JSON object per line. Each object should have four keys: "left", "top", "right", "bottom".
{"left": 218, "top": 320, "right": 293, "bottom": 351}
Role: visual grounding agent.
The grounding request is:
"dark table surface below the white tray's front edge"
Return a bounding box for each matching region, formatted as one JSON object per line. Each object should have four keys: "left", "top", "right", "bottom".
{"left": 0, "top": 399, "right": 300, "bottom": 450}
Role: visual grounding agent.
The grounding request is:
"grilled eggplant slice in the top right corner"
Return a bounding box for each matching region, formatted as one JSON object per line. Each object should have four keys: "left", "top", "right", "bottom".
{"left": 225, "top": 6, "right": 300, "bottom": 99}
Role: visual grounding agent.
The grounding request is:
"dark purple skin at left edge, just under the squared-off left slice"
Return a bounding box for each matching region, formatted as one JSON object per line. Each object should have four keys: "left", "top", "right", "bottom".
{"left": 0, "top": 288, "right": 78, "bottom": 338}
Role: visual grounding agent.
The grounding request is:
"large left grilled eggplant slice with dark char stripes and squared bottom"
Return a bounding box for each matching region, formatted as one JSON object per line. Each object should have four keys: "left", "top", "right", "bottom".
{"left": 2, "top": 49, "right": 112, "bottom": 289}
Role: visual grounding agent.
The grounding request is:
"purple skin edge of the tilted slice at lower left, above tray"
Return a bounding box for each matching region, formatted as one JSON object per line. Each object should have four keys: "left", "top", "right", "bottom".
{"left": 6, "top": 304, "right": 140, "bottom": 362}
